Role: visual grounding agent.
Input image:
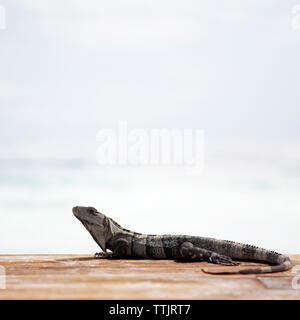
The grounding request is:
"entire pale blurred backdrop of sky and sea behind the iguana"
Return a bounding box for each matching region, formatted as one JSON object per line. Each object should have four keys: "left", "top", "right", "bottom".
{"left": 0, "top": 0, "right": 300, "bottom": 253}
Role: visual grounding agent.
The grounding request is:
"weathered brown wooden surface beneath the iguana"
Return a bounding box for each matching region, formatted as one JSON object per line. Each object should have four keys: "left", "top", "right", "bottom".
{"left": 0, "top": 255, "right": 300, "bottom": 299}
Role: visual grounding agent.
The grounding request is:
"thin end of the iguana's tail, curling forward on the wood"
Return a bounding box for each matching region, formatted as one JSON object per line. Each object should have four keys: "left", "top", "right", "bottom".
{"left": 202, "top": 255, "right": 292, "bottom": 274}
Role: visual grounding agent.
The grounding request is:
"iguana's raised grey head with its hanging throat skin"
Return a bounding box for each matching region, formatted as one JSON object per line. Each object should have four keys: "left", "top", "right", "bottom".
{"left": 72, "top": 207, "right": 110, "bottom": 251}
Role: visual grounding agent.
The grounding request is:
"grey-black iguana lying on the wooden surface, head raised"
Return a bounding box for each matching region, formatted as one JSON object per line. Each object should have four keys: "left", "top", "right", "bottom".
{"left": 73, "top": 207, "right": 291, "bottom": 274}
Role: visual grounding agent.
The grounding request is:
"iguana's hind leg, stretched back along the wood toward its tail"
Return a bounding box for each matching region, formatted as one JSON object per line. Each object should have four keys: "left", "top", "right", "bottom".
{"left": 180, "top": 242, "right": 238, "bottom": 266}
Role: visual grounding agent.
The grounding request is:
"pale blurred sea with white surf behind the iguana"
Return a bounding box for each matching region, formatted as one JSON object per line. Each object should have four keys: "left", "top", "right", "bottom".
{"left": 0, "top": 137, "right": 300, "bottom": 254}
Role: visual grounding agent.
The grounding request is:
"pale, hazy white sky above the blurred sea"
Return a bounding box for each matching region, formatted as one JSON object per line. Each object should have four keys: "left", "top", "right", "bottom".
{"left": 0, "top": 0, "right": 300, "bottom": 156}
